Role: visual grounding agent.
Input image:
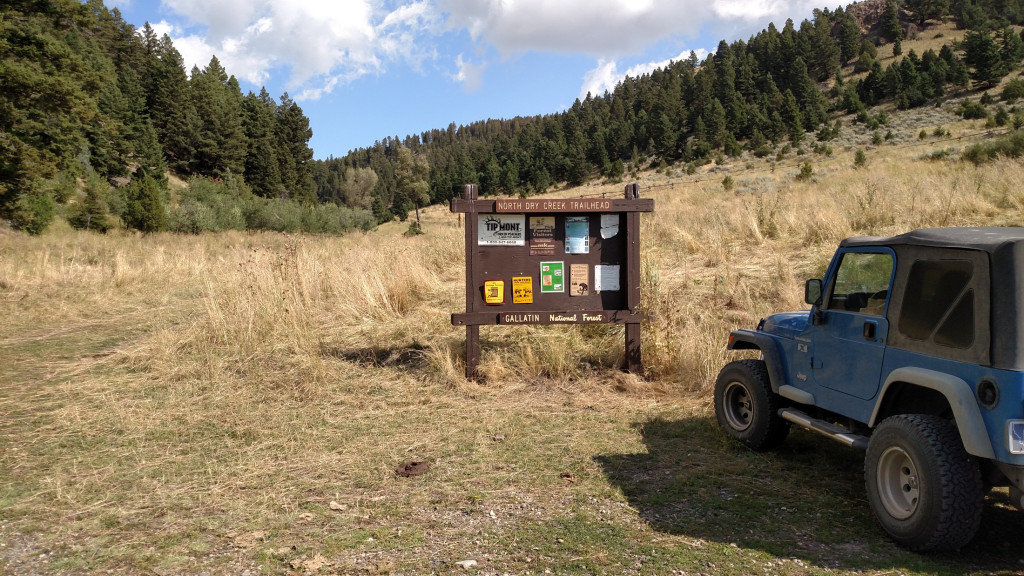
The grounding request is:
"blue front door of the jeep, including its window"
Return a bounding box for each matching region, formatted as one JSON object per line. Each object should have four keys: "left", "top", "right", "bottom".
{"left": 808, "top": 249, "right": 895, "bottom": 400}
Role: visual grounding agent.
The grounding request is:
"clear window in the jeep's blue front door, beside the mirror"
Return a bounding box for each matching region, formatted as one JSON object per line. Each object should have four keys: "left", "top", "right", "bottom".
{"left": 826, "top": 252, "right": 893, "bottom": 316}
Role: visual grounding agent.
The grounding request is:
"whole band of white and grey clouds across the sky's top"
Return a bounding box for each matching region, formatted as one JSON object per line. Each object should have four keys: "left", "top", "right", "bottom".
{"left": 155, "top": 0, "right": 835, "bottom": 99}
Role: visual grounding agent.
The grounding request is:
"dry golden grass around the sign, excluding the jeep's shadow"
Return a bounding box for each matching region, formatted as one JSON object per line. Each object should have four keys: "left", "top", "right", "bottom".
{"left": 6, "top": 136, "right": 1024, "bottom": 573}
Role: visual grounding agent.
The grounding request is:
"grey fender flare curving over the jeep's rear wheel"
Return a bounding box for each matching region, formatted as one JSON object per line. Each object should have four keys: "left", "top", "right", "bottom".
{"left": 867, "top": 367, "right": 995, "bottom": 459}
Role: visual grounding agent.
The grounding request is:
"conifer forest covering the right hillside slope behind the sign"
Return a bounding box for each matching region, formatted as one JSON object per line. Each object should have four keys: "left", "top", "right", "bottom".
{"left": 323, "top": 0, "right": 1024, "bottom": 221}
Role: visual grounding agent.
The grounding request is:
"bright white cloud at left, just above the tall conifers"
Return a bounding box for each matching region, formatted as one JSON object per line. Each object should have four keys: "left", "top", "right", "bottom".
{"left": 155, "top": 0, "right": 432, "bottom": 98}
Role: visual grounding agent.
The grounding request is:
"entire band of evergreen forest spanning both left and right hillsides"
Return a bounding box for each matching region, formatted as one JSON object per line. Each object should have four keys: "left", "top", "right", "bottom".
{"left": 0, "top": 0, "right": 1024, "bottom": 233}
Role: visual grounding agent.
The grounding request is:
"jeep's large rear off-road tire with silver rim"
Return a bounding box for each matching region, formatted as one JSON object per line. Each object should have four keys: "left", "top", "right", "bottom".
{"left": 864, "top": 414, "right": 984, "bottom": 551}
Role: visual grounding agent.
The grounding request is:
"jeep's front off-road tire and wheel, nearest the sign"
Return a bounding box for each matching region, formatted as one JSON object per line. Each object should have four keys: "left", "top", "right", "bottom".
{"left": 715, "top": 360, "right": 790, "bottom": 450}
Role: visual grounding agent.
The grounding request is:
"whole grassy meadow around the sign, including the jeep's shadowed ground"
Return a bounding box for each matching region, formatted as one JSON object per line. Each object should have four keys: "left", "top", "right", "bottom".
{"left": 0, "top": 105, "right": 1024, "bottom": 576}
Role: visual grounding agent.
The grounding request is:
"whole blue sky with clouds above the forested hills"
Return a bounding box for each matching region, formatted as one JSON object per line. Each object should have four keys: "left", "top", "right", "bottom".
{"left": 105, "top": 0, "right": 846, "bottom": 159}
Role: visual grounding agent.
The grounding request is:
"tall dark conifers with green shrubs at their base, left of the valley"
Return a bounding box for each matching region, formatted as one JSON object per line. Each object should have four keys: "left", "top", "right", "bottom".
{"left": 0, "top": 0, "right": 374, "bottom": 233}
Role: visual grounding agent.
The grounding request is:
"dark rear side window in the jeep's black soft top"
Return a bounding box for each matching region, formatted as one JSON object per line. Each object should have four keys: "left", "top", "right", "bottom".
{"left": 899, "top": 260, "right": 974, "bottom": 348}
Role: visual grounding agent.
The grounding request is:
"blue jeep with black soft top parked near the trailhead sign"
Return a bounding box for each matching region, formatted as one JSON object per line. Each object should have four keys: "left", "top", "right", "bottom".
{"left": 715, "top": 228, "right": 1024, "bottom": 551}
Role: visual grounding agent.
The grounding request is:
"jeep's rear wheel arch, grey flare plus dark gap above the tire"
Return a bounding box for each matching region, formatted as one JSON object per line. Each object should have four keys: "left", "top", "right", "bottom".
{"left": 868, "top": 367, "right": 995, "bottom": 458}
